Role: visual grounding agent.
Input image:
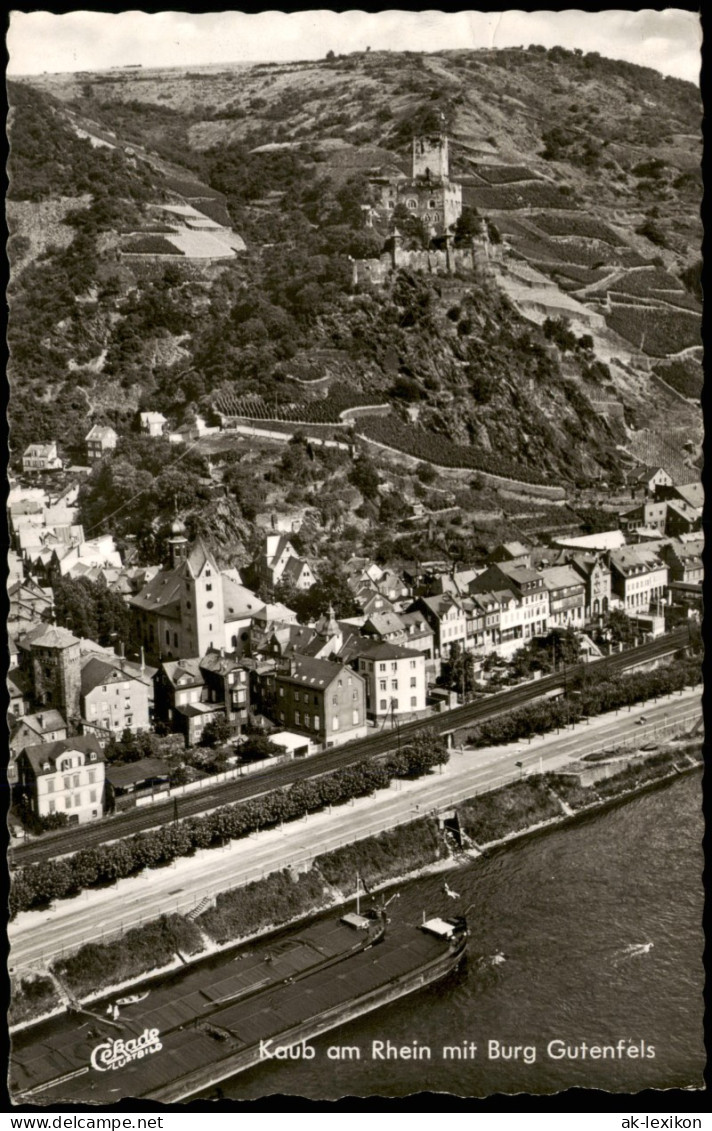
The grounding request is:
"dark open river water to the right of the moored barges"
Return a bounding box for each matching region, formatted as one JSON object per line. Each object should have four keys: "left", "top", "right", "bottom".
{"left": 214, "top": 774, "right": 704, "bottom": 1099}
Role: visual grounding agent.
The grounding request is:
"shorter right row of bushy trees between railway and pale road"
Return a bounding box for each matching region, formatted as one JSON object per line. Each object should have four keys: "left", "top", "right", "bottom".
{"left": 468, "top": 661, "right": 700, "bottom": 746}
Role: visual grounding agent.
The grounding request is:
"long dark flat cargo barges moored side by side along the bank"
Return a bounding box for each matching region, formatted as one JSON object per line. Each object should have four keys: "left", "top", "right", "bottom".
{"left": 10, "top": 907, "right": 468, "bottom": 1105}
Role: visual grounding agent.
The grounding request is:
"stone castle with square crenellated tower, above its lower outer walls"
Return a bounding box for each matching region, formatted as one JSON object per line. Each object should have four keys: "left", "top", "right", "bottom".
{"left": 371, "top": 132, "right": 462, "bottom": 238}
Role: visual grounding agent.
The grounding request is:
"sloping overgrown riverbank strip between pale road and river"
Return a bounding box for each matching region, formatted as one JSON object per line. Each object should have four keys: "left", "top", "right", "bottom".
{"left": 10, "top": 742, "right": 701, "bottom": 1031}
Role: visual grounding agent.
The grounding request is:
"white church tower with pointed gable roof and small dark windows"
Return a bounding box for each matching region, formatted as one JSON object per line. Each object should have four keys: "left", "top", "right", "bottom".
{"left": 180, "top": 538, "right": 225, "bottom": 656}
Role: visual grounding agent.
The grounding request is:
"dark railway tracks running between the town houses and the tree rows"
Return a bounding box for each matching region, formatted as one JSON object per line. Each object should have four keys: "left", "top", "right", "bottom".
{"left": 11, "top": 628, "right": 688, "bottom": 867}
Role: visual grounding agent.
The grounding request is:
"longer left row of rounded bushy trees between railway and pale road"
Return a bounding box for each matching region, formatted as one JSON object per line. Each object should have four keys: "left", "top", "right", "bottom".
{"left": 9, "top": 741, "right": 449, "bottom": 917}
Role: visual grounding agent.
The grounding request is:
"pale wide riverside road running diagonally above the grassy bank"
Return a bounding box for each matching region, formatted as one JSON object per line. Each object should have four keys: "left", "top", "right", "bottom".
{"left": 9, "top": 691, "right": 702, "bottom": 970}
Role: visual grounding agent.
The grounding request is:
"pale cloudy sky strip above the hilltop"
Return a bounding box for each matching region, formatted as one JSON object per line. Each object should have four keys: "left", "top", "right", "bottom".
{"left": 7, "top": 8, "right": 702, "bottom": 84}
